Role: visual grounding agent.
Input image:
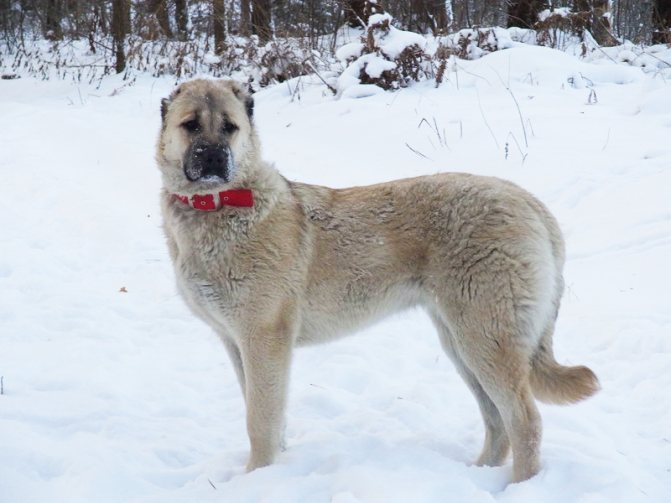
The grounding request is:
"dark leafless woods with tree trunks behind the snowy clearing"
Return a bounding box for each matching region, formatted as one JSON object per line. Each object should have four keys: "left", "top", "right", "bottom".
{"left": 0, "top": 0, "right": 671, "bottom": 78}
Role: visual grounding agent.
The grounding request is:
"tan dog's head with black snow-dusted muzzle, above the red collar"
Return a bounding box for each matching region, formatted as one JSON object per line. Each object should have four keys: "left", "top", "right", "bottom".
{"left": 156, "top": 79, "right": 257, "bottom": 194}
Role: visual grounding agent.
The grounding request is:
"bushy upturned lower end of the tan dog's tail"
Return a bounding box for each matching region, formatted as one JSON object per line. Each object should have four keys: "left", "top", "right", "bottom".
{"left": 530, "top": 330, "right": 601, "bottom": 404}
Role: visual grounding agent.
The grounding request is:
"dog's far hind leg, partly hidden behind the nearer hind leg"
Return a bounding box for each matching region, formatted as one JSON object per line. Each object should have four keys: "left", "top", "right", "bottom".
{"left": 430, "top": 312, "right": 510, "bottom": 466}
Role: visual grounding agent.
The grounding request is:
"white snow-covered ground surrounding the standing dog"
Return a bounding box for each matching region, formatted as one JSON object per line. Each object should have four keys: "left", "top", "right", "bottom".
{"left": 0, "top": 47, "right": 671, "bottom": 503}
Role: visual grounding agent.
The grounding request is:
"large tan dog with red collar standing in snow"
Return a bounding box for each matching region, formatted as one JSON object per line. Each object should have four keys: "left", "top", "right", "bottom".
{"left": 156, "top": 80, "right": 598, "bottom": 481}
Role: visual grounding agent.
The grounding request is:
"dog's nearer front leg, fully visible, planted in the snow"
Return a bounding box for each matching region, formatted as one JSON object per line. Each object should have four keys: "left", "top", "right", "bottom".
{"left": 240, "top": 322, "right": 293, "bottom": 471}
